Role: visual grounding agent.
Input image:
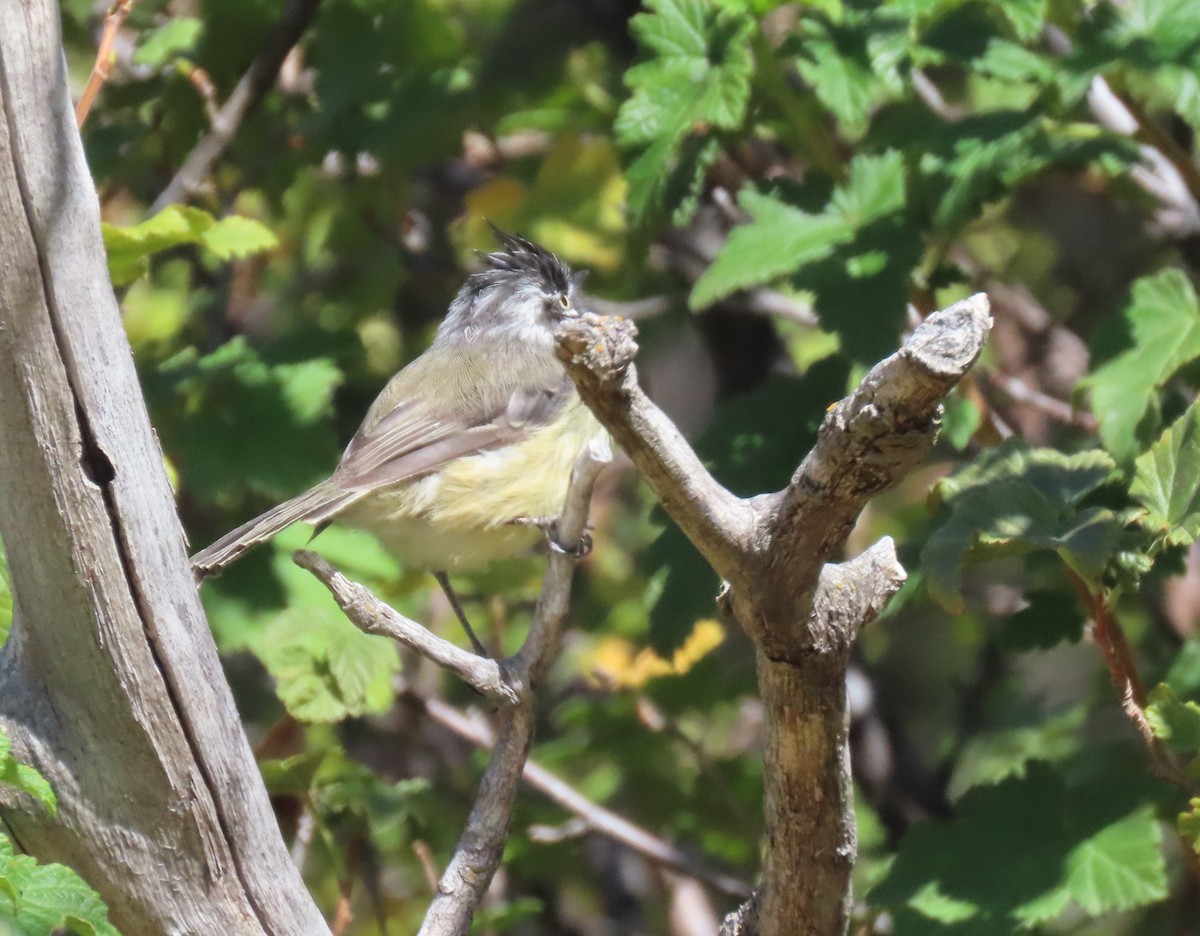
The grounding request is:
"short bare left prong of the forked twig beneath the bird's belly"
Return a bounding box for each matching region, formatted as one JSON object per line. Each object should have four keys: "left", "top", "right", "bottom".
{"left": 292, "top": 550, "right": 518, "bottom": 707}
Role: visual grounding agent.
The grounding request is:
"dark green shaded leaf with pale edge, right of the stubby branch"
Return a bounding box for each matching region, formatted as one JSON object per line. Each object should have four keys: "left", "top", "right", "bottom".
{"left": 922, "top": 440, "right": 1124, "bottom": 610}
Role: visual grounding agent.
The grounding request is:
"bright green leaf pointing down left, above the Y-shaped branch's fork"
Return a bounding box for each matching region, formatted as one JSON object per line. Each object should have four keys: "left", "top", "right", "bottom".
{"left": 688, "top": 151, "right": 905, "bottom": 308}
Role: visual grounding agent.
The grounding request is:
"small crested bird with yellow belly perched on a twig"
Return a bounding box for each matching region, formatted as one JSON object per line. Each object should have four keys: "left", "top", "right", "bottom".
{"left": 192, "top": 228, "right": 604, "bottom": 649}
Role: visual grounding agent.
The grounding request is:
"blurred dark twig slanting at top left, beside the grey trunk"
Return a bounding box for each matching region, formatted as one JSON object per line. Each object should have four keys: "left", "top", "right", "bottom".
{"left": 150, "top": 0, "right": 320, "bottom": 214}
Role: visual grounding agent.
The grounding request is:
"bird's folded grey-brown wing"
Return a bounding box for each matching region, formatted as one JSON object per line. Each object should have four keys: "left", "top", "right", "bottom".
{"left": 331, "top": 373, "right": 575, "bottom": 496}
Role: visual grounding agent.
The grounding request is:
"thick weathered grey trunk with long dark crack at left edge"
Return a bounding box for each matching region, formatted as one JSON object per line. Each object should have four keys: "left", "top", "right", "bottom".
{"left": 0, "top": 0, "right": 329, "bottom": 936}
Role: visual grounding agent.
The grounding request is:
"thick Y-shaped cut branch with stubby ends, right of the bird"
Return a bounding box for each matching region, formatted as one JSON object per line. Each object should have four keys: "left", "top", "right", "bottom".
{"left": 558, "top": 295, "right": 991, "bottom": 936}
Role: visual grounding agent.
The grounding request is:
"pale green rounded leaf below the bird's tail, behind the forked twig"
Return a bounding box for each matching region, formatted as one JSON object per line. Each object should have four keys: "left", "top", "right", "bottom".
{"left": 259, "top": 607, "right": 400, "bottom": 722}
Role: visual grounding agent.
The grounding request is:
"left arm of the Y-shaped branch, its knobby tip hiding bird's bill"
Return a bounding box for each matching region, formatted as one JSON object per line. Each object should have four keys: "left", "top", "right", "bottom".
{"left": 557, "top": 314, "right": 754, "bottom": 578}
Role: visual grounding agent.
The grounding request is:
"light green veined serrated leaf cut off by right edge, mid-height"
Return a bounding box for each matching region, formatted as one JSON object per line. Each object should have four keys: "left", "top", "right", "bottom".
{"left": 1129, "top": 403, "right": 1200, "bottom": 546}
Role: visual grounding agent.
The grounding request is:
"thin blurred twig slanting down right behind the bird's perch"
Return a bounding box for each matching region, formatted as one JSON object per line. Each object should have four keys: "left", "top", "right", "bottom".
{"left": 418, "top": 698, "right": 750, "bottom": 900}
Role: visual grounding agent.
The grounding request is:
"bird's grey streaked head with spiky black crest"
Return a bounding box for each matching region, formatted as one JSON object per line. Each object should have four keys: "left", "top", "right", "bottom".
{"left": 437, "top": 226, "right": 583, "bottom": 348}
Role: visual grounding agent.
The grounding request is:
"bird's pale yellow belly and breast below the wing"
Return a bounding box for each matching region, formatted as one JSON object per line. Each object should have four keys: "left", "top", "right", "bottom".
{"left": 336, "top": 401, "right": 602, "bottom": 571}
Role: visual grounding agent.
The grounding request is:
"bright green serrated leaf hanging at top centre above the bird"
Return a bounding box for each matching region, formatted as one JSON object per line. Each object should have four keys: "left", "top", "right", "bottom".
{"left": 613, "top": 0, "right": 754, "bottom": 228}
